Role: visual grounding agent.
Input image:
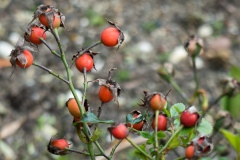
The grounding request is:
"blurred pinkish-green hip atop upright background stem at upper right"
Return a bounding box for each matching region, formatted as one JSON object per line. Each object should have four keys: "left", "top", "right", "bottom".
{"left": 184, "top": 35, "right": 204, "bottom": 57}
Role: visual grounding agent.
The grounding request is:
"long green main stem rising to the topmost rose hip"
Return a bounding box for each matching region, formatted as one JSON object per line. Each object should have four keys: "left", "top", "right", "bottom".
{"left": 50, "top": 28, "right": 95, "bottom": 160}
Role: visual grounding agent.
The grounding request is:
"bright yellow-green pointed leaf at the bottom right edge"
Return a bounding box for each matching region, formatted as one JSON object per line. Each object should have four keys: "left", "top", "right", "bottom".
{"left": 220, "top": 129, "right": 240, "bottom": 154}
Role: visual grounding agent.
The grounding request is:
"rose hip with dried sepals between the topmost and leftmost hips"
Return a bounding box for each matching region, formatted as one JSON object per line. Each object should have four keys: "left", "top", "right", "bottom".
{"left": 24, "top": 23, "right": 47, "bottom": 45}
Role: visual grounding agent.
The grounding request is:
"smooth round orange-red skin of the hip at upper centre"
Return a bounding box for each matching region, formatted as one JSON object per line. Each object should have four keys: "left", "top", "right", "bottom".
{"left": 101, "top": 27, "right": 121, "bottom": 47}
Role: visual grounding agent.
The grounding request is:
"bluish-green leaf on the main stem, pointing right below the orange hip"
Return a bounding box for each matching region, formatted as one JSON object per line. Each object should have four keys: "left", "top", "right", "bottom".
{"left": 80, "top": 112, "right": 114, "bottom": 124}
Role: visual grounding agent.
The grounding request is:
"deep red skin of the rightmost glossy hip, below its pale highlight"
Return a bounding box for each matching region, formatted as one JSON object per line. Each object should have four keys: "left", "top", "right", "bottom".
{"left": 180, "top": 110, "right": 199, "bottom": 127}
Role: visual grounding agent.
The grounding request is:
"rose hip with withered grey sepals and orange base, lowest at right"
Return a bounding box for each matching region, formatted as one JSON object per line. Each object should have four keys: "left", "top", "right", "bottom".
{"left": 185, "top": 135, "right": 213, "bottom": 159}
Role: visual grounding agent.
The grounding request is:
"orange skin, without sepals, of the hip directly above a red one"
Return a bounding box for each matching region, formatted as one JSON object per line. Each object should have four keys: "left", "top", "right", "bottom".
{"left": 149, "top": 94, "right": 167, "bottom": 111}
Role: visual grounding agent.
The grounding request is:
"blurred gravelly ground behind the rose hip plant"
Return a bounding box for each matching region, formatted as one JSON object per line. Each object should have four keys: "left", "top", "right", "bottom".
{"left": 0, "top": 0, "right": 240, "bottom": 160}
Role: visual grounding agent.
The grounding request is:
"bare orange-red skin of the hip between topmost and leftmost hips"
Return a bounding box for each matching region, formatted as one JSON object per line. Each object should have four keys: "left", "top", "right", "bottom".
{"left": 28, "top": 27, "right": 47, "bottom": 44}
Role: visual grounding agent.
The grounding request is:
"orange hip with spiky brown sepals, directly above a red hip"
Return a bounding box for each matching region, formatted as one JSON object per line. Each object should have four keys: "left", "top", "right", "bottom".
{"left": 139, "top": 91, "right": 169, "bottom": 111}
